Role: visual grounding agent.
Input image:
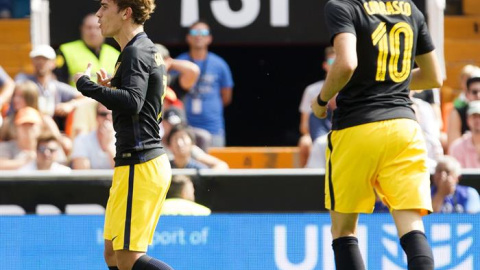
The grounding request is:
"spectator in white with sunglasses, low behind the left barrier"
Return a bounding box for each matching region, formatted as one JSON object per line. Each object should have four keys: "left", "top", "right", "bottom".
{"left": 19, "top": 136, "right": 71, "bottom": 173}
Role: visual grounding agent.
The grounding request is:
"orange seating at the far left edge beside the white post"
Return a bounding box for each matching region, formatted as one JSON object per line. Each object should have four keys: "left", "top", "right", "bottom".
{"left": 0, "top": 19, "right": 33, "bottom": 77}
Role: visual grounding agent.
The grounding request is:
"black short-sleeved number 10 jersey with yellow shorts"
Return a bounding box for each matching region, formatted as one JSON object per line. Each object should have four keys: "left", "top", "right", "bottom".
{"left": 325, "top": 0, "right": 434, "bottom": 213}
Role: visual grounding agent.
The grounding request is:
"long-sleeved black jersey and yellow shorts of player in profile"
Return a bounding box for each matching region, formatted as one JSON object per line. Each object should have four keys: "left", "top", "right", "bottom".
{"left": 77, "top": 32, "right": 171, "bottom": 251}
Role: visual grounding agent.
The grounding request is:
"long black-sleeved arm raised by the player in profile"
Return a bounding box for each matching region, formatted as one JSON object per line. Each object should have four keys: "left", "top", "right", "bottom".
{"left": 76, "top": 47, "right": 148, "bottom": 114}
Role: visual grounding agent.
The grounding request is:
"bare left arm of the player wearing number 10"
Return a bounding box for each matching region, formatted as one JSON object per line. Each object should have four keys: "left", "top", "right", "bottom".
{"left": 312, "top": 33, "right": 358, "bottom": 118}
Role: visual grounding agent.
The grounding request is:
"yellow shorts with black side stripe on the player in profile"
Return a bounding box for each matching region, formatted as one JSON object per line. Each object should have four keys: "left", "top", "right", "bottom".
{"left": 104, "top": 154, "right": 172, "bottom": 252}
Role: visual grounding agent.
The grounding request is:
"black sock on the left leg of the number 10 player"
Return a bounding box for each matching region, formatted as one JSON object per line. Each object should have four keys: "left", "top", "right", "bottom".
{"left": 332, "top": 236, "right": 365, "bottom": 270}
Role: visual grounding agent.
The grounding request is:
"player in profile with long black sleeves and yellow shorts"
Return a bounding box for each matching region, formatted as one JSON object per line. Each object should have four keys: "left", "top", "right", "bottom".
{"left": 75, "top": 0, "right": 172, "bottom": 270}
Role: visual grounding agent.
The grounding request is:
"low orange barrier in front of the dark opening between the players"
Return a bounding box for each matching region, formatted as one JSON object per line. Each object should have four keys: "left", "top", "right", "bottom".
{"left": 209, "top": 147, "right": 299, "bottom": 169}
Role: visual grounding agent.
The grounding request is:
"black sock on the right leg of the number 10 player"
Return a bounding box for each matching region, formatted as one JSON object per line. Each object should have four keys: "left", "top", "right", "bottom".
{"left": 400, "top": 231, "right": 434, "bottom": 270}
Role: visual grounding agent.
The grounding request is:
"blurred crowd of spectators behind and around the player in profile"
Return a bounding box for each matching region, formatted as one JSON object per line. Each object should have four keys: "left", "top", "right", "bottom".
{"left": 0, "top": 14, "right": 233, "bottom": 171}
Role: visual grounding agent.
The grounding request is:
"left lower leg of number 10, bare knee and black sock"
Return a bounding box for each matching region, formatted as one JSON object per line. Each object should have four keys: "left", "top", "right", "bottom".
{"left": 330, "top": 211, "right": 365, "bottom": 270}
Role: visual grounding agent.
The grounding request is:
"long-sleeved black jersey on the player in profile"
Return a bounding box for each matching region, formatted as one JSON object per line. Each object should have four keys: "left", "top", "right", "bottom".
{"left": 77, "top": 32, "right": 167, "bottom": 166}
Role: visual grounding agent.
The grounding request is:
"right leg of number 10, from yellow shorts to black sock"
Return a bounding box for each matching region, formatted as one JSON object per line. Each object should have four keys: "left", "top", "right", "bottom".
{"left": 376, "top": 119, "right": 434, "bottom": 270}
